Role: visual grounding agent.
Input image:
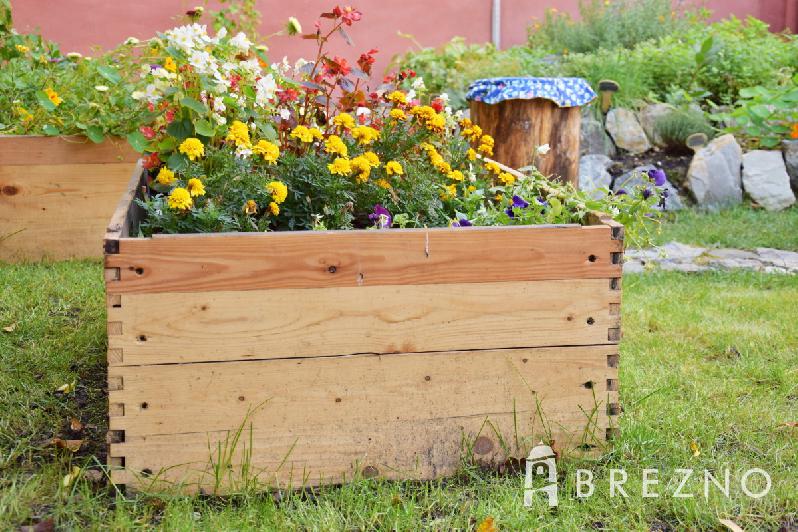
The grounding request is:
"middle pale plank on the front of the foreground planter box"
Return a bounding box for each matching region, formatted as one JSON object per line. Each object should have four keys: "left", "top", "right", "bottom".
{"left": 108, "top": 279, "right": 620, "bottom": 365}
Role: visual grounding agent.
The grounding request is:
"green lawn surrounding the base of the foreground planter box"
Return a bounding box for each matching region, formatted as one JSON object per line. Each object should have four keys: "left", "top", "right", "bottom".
{"left": 0, "top": 258, "right": 798, "bottom": 530}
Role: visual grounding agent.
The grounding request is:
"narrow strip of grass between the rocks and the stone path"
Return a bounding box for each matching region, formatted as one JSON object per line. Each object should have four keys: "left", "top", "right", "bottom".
{"left": 656, "top": 205, "right": 798, "bottom": 251}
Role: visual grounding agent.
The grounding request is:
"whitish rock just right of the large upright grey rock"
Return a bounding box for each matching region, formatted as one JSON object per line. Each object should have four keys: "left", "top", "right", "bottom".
{"left": 743, "top": 150, "right": 795, "bottom": 211}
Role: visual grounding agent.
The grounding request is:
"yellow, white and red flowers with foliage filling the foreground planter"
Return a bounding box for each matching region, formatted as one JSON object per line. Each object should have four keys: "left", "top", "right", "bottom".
{"left": 129, "top": 7, "right": 659, "bottom": 246}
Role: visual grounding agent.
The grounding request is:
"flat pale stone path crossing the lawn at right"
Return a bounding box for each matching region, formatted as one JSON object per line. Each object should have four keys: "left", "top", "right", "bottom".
{"left": 623, "top": 242, "right": 798, "bottom": 274}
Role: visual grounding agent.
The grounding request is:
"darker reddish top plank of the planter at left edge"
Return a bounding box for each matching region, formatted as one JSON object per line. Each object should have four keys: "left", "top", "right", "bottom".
{"left": 0, "top": 135, "right": 139, "bottom": 166}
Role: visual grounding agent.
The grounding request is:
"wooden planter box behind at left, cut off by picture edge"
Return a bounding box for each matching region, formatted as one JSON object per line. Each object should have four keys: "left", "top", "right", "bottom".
{"left": 0, "top": 135, "right": 138, "bottom": 261}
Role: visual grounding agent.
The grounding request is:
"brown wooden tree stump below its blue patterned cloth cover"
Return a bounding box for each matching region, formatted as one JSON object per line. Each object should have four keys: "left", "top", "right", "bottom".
{"left": 469, "top": 98, "right": 582, "bottom": 187}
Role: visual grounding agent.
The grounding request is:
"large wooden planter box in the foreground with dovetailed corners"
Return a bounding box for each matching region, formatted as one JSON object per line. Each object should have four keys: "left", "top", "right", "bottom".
{"left": 105, "top": 166, "right": 623, "bottom": 493}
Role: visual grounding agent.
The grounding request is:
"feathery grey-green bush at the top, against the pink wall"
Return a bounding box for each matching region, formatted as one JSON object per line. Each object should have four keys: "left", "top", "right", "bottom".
{"left": 529, "top": 0, "right": 685, "bottom": 53}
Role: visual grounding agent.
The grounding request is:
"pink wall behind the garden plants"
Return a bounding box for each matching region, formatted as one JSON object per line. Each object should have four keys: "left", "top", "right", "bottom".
{"left": 11, "top": 0, "right": 798, "bottom": 78}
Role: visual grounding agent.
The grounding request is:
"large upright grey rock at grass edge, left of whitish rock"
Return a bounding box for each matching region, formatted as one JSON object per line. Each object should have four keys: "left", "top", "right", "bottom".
{"left": 687, "top": 134, "right": 743, "bottom": 209}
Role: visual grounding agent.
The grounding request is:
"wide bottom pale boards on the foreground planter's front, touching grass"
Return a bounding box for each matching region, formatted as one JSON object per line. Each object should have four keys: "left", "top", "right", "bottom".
{"left": 109, "top": 346, "right": 617, "bottom": 488}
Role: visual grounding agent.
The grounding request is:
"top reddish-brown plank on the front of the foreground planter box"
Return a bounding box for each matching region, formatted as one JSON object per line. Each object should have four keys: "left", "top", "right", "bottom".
{"left": 106, "top": 225, "right": 622, "bottom": 294}
